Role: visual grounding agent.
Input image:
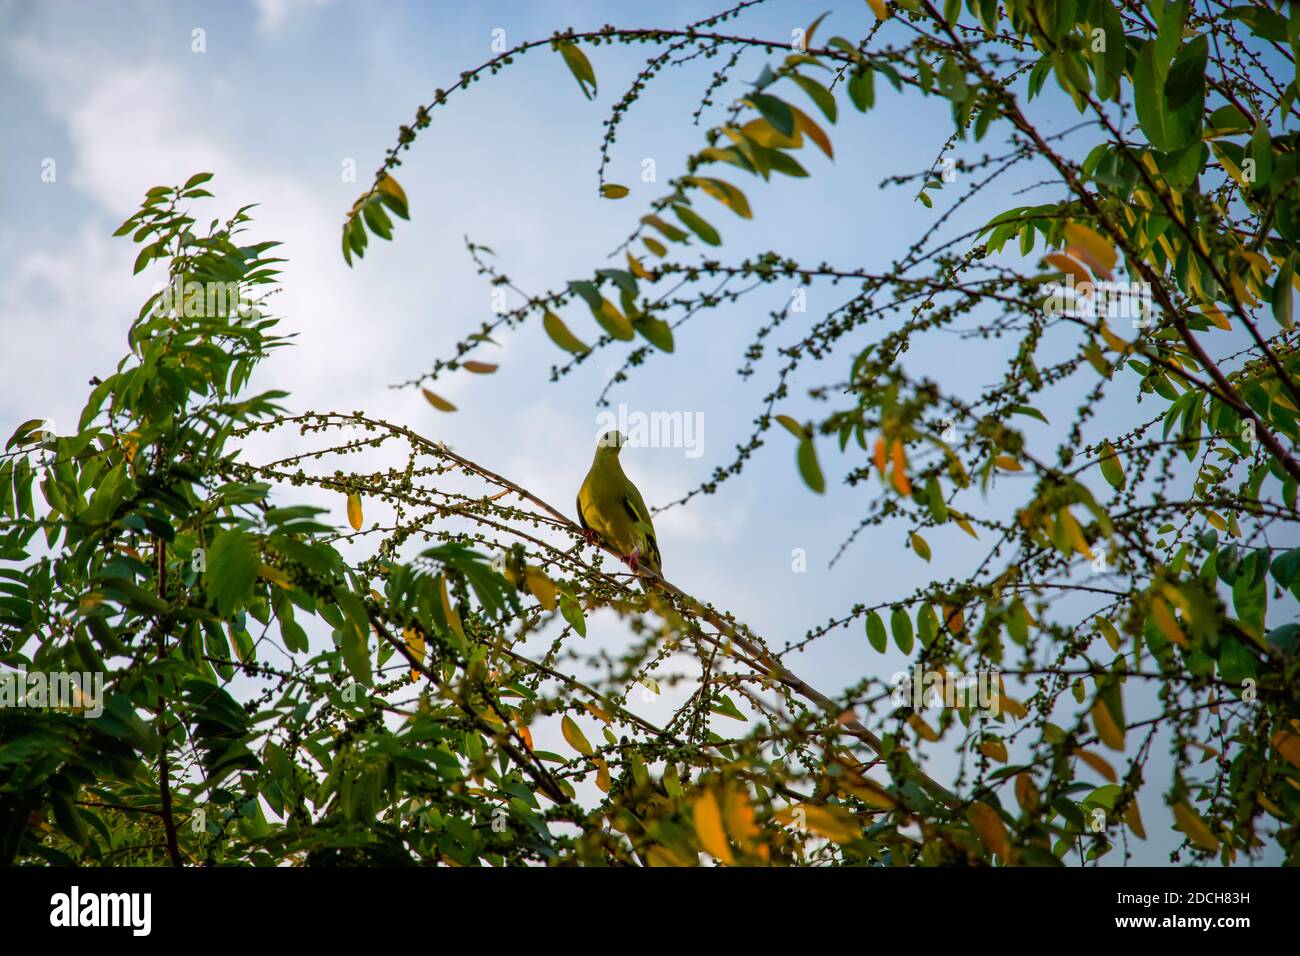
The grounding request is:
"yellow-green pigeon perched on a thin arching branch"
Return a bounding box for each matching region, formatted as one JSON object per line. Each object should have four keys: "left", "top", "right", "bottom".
{"left": 577, "top": 432, "right": 663, "bottom": 591}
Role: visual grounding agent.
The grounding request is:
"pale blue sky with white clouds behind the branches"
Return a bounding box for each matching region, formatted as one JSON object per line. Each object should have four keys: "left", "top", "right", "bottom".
{"left": 0, "top": 0, "right": 1279, "bottom": 862}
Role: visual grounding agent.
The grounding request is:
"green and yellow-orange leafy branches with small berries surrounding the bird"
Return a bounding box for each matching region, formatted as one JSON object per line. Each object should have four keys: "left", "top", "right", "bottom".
{"left": 0, "top": 0, "right": 1300, "bottom": 865}
